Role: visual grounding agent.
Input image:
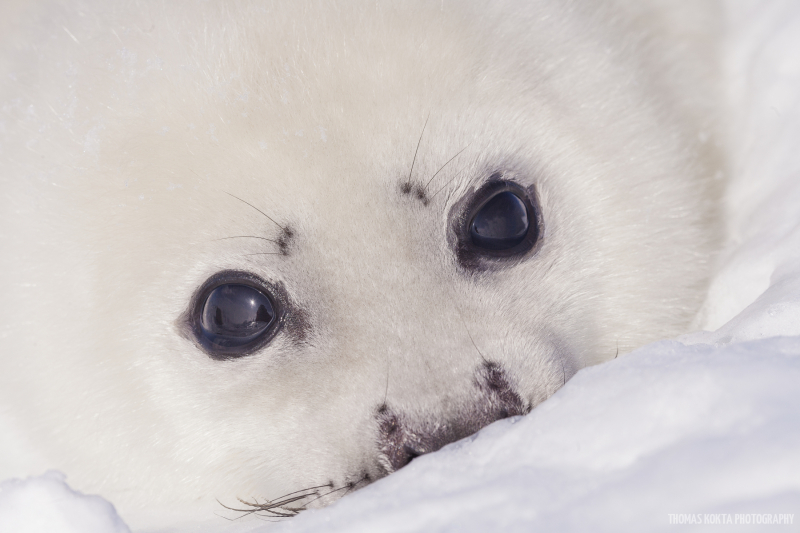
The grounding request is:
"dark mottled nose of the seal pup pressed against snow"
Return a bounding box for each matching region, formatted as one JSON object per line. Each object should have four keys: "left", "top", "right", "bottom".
{"left": 377, "top": 361, "right": 530, "bottom": 474}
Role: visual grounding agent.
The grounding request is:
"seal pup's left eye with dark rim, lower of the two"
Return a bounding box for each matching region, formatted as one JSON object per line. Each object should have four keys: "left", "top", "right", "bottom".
{"left": 189, "top": 271, "right": 281, "bottom": 359}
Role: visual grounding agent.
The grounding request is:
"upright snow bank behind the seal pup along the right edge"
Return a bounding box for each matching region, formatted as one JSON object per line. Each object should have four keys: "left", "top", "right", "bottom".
{"left": 693, "top": 0, "right": 800, "bottom": 343}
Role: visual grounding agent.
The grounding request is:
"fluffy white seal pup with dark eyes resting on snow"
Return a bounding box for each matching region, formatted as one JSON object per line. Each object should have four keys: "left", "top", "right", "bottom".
{"left": 0, "top": 0, "right": 722, "bottom": 525}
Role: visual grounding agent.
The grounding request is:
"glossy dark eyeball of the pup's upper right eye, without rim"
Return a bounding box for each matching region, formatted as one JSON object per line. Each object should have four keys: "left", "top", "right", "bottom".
{"left": 469, "top": 191, "right": 530, "bottom": 250}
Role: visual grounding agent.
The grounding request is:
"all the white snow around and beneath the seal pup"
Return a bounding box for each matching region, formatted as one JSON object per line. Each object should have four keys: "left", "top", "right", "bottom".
{"left": 0, "top": 0, "right": 800, "bottom": 533}
